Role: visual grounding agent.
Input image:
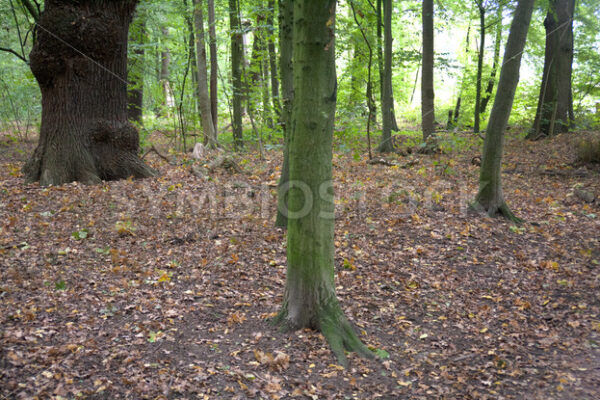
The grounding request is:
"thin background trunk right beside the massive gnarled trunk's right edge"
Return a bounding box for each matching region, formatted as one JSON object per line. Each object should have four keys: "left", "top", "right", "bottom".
{"left": 127, "top": 11, "right": 146, "bottom": 125}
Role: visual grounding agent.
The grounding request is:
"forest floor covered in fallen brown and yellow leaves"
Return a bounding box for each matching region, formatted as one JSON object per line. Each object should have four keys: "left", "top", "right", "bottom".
{"left": 0, "top": 133, "right": 600, "bottom": 399}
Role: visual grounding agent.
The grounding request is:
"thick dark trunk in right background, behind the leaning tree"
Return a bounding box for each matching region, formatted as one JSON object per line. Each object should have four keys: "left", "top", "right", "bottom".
{"left": 527, "top": 0, "right": 575, "bottom": 139}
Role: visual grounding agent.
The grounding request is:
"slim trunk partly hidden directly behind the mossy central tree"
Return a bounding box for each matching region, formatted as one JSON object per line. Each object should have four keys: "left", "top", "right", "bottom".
{"left": 275, "top": 0, "right": 294, "bottom": 228}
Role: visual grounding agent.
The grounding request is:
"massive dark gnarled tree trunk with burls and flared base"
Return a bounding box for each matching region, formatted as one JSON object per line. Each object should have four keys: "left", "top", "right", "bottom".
{"left": 23, "top": 0, "right": 155, "bottom": 186}
